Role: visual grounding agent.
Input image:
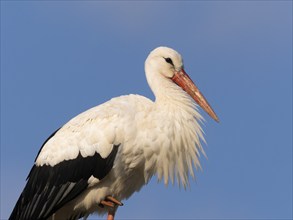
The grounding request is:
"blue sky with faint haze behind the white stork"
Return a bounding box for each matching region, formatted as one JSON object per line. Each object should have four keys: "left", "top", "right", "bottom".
{"left": 0, "top": 1, "right": 292, "bottom": 219}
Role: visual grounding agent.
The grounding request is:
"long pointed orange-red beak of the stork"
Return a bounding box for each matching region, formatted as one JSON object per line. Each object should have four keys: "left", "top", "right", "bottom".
{"left": 171, "top": 69, "right": 219, "bottom": 122}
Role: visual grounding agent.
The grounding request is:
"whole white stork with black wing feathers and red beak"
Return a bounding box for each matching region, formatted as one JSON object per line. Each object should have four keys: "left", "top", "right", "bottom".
{"left": 9, "top": 47, "right": 218, "bottom": 220}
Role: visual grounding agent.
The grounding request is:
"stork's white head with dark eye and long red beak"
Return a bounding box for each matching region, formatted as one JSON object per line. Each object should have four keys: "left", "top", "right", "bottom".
{"left": 145, "top": 47, "right": 219, "bottom": 122}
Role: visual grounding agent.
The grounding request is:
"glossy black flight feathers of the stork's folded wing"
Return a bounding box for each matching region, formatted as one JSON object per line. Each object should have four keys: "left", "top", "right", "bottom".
{"left": 9, "top": 130, "right": 119, "bottom": 220}
